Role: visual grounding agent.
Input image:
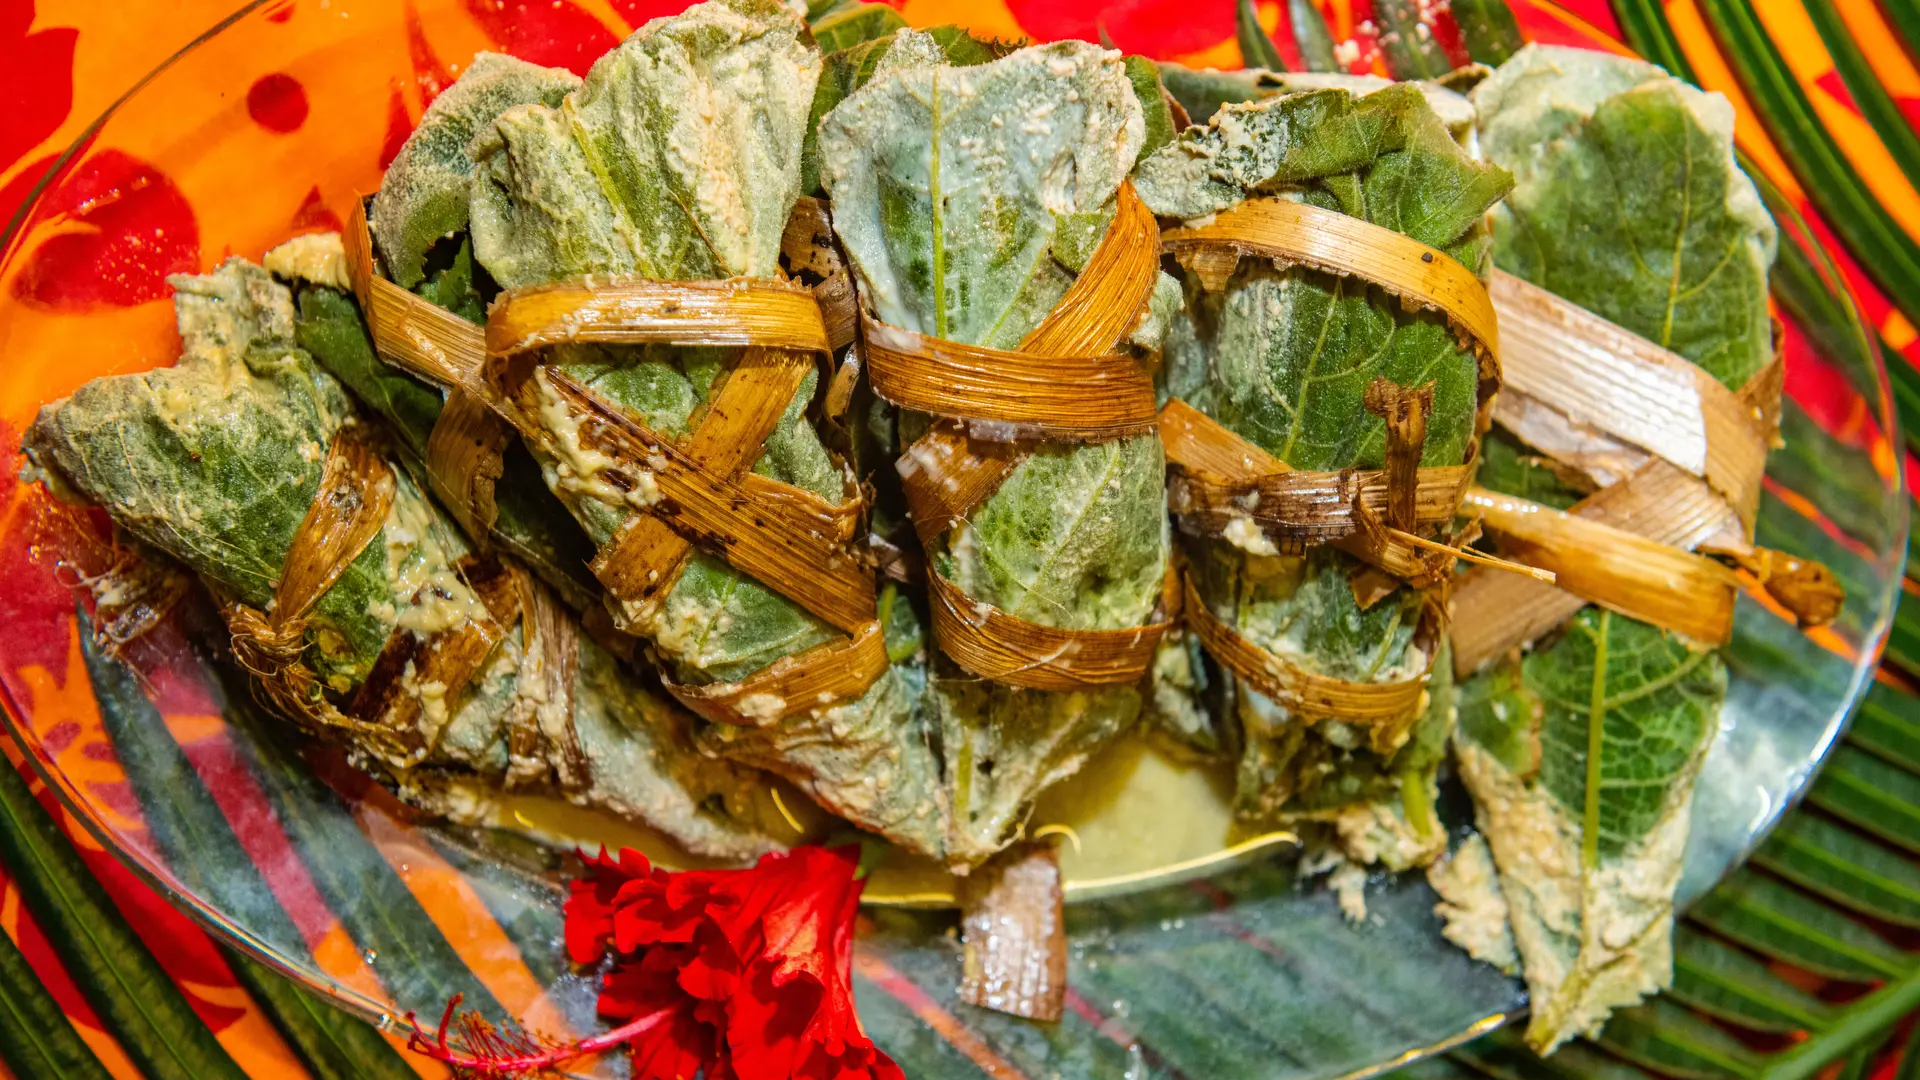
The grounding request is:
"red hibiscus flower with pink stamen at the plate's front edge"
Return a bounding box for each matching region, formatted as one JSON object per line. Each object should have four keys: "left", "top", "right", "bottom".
{"left": 413, "top": 847, "right": 904, "bottom": 1080}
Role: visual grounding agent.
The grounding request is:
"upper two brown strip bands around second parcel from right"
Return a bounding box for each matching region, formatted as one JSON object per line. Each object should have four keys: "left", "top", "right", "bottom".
{"left": 1160, "top": 198, "right": 1501, "bottom": 564}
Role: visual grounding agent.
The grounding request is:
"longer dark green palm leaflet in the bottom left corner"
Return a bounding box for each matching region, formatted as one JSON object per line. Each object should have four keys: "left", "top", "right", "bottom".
{"left": 0, "top": 749, "right": 246, "bottom": 1080}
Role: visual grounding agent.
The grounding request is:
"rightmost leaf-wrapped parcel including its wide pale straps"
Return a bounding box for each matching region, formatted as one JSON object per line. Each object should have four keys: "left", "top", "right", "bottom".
{"left": 1438, "top": 46, "right": 1841, "bottom": 1053}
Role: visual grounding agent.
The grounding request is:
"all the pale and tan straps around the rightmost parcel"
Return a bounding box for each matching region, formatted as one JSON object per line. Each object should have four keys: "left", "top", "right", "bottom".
{"left": 1452, "top": 273, "right": 1843, "bottom": 675}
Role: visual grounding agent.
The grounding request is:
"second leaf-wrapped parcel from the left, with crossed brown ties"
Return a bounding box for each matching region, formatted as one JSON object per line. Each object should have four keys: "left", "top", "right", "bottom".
{"left": 349, "top": 0, "right": 945, "bottom": 855}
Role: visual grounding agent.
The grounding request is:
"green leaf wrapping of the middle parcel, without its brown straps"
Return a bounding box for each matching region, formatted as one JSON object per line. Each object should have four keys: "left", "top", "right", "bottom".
{"left": 820, "top": 31, "right": 1171, "bottom": 865}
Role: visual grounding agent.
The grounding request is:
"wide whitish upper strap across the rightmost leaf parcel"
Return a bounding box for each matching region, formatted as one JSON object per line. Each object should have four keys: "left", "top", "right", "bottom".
{"left": 1492, "top": 271, "right": 1780, "bottom": 536}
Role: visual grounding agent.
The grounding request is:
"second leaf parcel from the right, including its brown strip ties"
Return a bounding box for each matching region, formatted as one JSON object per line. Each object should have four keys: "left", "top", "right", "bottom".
{"left": 1135, "top": 83, "right": 1511, "bottom": 869}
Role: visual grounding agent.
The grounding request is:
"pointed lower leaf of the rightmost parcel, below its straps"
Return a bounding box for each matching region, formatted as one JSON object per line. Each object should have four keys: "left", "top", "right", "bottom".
{"left": 1457, "top": 607, "right": 1726, "bottom": 1047}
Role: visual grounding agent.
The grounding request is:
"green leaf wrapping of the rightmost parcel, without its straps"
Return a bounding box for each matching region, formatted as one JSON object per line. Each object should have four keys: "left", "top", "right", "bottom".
{"left": 1455, "top": 46, "right": 1774, "bottom": 1051}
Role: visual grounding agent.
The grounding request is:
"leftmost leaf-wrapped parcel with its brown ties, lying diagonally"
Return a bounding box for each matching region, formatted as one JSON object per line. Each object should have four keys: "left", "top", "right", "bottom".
{"left": 25, "top": 254, "right": 770, "bottom": 857}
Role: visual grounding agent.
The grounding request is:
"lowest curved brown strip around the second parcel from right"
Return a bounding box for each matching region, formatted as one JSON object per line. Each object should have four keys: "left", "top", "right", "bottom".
{"left": 1185, "top": 580, "right": 1444, "bottom": 753}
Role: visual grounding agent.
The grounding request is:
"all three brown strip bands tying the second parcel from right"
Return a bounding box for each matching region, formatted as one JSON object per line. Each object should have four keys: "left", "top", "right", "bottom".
{"left": 1160, "top": 198, "right": 1501, "bottom": 730}
